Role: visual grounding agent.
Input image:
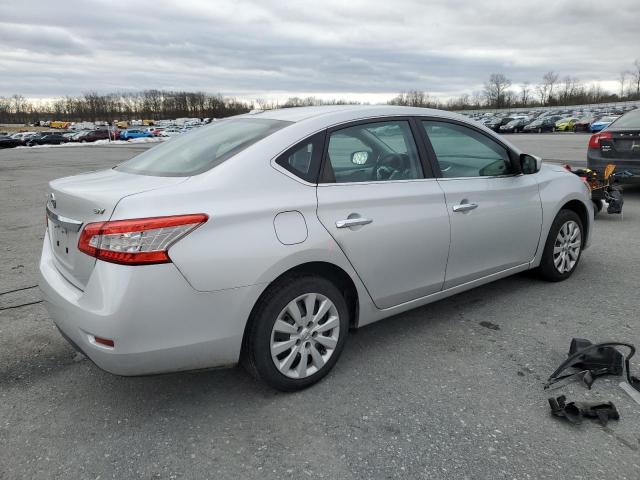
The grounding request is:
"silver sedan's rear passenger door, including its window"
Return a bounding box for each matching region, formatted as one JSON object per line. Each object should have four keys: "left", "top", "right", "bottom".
{"left": 317, "top": 118, "right": 450, "bottom": 308}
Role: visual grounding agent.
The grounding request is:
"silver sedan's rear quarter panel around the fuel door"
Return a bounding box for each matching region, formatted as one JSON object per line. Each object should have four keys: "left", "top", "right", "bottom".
{"left": 112, "top": 141, "right": 367, "bottom": 306}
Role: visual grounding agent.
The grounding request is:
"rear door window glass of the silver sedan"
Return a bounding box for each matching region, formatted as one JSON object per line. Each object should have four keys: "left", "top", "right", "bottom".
{"left": 322, "top": 120, "right": 424, "bottom": 183}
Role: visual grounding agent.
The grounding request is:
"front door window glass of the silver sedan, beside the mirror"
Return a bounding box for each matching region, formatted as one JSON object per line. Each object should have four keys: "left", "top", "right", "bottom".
{"left": 422, "top": 121, "right": 514, "bottom": 178}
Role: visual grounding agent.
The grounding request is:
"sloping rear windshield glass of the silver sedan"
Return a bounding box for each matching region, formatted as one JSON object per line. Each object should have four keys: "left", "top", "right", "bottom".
{"left": 115, "top": 117, "right": 290, "bottom": 177}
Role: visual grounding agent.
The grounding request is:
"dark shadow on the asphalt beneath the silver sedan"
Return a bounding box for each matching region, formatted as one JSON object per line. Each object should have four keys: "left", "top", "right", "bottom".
{"left": 0, "top": 275, "right": 537, "bottom": 410}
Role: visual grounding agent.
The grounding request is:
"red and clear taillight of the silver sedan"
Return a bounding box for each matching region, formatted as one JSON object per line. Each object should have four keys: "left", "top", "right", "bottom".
{"left": 78, "top": 213, "right": 209, "bottom": 265}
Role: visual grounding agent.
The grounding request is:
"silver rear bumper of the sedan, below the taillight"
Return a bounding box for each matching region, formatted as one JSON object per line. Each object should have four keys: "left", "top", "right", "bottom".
{"left": 40, "top": 232, "right": 260, "bottom": 375}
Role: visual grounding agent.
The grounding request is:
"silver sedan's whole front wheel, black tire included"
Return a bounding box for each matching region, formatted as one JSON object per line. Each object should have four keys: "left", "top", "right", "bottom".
{"left": 538, "top": 209, "right": 584, "bottom": 282}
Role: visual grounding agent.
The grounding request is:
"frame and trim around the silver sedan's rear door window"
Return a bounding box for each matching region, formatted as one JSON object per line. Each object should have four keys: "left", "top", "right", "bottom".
{"left": 318, "top": 115, "right": 435, "bottom": 186}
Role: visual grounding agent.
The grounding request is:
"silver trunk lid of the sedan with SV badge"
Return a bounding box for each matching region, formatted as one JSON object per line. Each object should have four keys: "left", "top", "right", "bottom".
{"left": 47, "top": 170, "right": 187, "bottom": 290}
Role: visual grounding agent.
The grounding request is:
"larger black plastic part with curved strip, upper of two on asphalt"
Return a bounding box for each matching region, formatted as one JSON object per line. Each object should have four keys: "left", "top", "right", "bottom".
{"left": 544, "top": 338, "right": 640, "bottom": 392}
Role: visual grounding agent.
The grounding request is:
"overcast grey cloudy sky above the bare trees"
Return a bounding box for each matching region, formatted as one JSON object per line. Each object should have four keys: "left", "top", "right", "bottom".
{"left": 0, "top": 0, "right": 640, "bottom": 102}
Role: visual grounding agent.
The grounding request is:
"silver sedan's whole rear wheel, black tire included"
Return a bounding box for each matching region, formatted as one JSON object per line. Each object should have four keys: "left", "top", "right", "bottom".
{"left": 243, "top": 275, "right": 349, "bottom": 392}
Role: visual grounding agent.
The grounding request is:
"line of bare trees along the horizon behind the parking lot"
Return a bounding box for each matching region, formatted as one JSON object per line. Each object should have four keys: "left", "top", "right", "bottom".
{"left": 0, "top": 60, "right": 640, "bottom": 123}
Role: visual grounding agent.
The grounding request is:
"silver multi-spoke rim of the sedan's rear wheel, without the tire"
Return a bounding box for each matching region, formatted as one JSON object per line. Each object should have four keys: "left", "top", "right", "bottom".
{"left": 270, "top": 293, "right": 340, "bottom": 379}
